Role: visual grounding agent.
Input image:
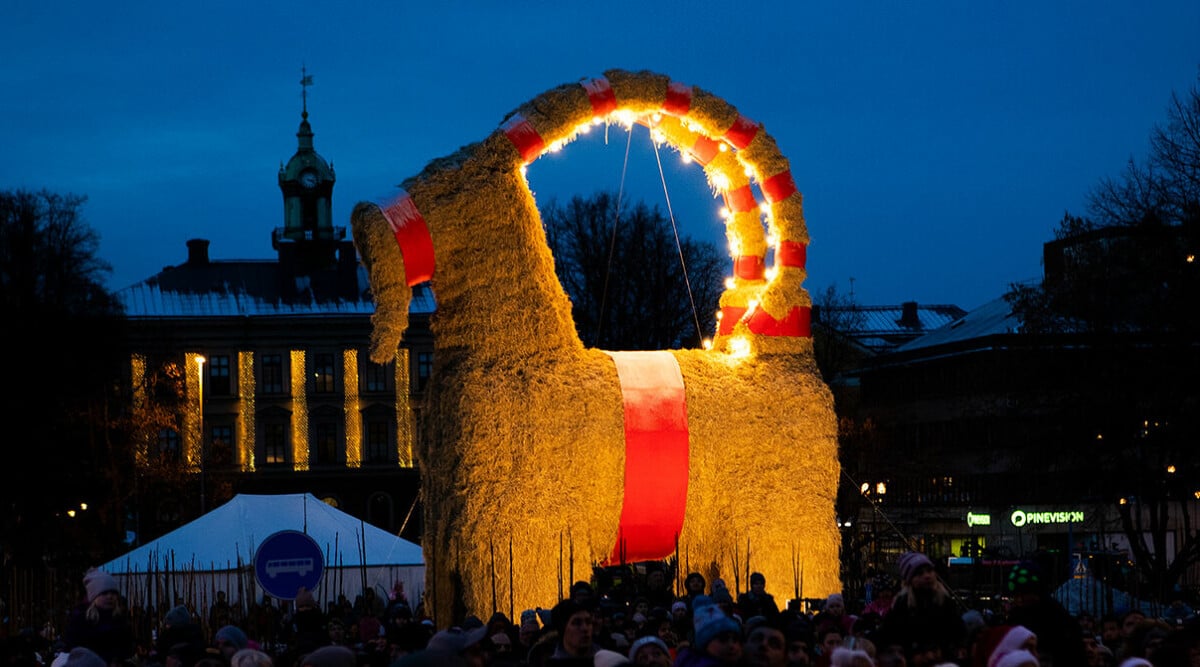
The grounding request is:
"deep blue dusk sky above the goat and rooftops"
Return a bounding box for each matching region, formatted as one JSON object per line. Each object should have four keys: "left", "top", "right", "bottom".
{"left": 0, "top": 0, "right": 1200, "bottom": 310}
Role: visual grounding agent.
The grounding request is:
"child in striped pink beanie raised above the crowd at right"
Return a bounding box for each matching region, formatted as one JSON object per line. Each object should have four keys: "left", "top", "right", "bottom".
{"left": 875, "top": 552, "right": 966, "bottom": 665}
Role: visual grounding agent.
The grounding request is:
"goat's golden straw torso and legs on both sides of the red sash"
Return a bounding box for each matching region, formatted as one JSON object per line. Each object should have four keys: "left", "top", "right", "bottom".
{"left": 418, "top": 350, "right": 839, "bottom": 614}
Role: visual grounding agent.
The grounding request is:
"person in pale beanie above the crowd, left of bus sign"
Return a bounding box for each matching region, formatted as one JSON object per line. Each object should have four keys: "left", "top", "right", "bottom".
{"left": 62, "top": 569, "right": 134, "bottom": 662}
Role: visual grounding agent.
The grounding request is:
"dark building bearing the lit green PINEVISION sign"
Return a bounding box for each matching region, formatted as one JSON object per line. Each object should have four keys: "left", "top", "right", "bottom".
{"left": 839, "top": 299, "right": 1200, "bottom": 612}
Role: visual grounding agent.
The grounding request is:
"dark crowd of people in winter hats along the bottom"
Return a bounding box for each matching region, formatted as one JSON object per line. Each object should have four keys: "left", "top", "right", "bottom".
{"left": 4, "top": 552, "right": 1200, "bottom": 667}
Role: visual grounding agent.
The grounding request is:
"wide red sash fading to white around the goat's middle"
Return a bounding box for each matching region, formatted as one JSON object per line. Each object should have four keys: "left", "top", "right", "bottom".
{"left": 607, "top": 351, "right": 688, "bottom": 565}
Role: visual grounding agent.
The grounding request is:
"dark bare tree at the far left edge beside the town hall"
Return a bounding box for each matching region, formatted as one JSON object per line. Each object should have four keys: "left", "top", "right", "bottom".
{"left": 0, "top": 191, "right": 125, "bottom": 561}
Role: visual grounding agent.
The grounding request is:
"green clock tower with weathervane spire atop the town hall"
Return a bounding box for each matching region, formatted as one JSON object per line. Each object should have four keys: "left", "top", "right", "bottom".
{"left": 271, "top": 70, "right": 353, "bottom": 271}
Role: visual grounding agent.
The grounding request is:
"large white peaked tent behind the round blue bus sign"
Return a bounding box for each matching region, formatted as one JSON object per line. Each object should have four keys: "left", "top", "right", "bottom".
{"left": 101, "top": 493, "right": 425, "bottom": 609}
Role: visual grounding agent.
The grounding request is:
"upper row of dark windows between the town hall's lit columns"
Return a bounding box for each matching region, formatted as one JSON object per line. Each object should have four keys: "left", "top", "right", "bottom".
{"left": 204, "top": 351, "right": 433, "bottom": 396}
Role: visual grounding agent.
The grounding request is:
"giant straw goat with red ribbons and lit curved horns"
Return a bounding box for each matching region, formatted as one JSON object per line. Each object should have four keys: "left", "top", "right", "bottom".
{"left": 353, "top": 70, "right": 840, "bottom": 618}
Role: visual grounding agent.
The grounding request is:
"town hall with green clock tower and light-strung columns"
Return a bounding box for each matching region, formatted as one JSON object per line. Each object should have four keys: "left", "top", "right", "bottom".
{"left": 118, "top": 95, "right": 434, "bottom": 540}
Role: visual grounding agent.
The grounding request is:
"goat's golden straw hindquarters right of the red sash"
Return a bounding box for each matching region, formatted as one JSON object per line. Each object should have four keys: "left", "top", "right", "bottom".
{"left": 677, "top": 350, "right": 840, "bottom": 605}
